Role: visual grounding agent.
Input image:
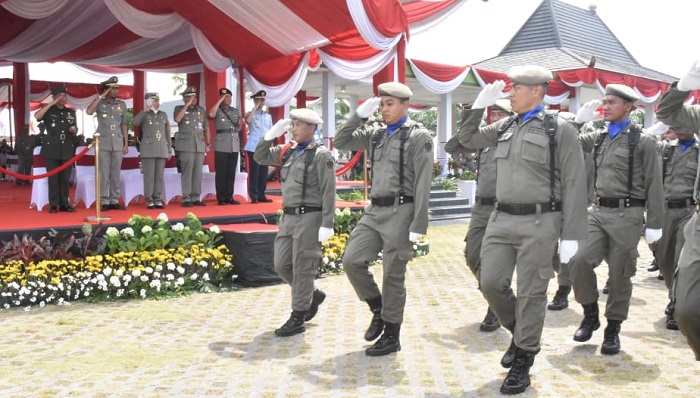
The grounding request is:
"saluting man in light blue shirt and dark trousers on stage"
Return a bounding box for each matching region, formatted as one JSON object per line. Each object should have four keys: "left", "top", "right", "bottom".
{"left": 245, "top": 90, "right": 272, "bottom": 203}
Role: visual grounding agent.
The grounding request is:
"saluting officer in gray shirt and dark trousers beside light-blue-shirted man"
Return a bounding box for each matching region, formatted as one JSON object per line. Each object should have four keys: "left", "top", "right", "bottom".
{"left": 207, "top": 87, "right": 243, "bottom": 205}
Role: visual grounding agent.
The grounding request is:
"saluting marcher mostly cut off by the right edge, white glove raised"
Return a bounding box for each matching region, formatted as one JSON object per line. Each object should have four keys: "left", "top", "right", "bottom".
{"left": 656, "top": 62, "right": 700, "bottom": 361}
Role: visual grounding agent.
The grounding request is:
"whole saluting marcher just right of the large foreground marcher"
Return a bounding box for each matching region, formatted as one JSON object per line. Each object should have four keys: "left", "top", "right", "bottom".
{"left": 571, "top": 84, "right": 663, "bottom": 355}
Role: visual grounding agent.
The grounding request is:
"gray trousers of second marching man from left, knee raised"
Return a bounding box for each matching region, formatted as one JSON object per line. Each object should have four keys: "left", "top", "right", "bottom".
{"left": 343, "top": 203, "right": 414, "bottom": 323}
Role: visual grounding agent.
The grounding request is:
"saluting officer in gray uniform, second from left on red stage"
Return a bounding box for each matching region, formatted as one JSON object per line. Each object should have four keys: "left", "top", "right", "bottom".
{"left": 85, "top": 76, "right": 129, "bottom": 211}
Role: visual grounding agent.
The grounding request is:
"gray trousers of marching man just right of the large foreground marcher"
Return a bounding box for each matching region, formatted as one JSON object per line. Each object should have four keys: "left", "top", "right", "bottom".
{"left": 571, "top": 205, "right": 644, "bottom": 321}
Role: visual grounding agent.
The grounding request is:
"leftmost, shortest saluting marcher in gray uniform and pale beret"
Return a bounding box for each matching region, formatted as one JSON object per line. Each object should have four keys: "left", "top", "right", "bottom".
{"left": 254, "top": 109, "right": 335, "bottom": 337}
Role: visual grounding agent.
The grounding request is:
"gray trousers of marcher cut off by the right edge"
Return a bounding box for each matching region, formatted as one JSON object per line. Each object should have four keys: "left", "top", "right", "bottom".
{"left": 674, "top": 211, "right": 700, "bottom": 361}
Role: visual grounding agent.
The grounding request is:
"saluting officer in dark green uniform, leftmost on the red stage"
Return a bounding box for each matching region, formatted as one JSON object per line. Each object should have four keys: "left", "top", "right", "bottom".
{"left": 34, "top": 86, "right": 78, "bottom": 213}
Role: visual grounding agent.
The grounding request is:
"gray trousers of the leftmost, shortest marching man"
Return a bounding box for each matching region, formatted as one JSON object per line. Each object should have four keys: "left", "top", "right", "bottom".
{"left": 274, "top": 211, "right": 323, "bottom": 311}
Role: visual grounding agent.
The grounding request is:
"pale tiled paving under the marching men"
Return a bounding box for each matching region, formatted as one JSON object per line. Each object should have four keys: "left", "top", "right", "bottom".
{"left": 0, "top": 224, "right": 700, "bottom": 398}
